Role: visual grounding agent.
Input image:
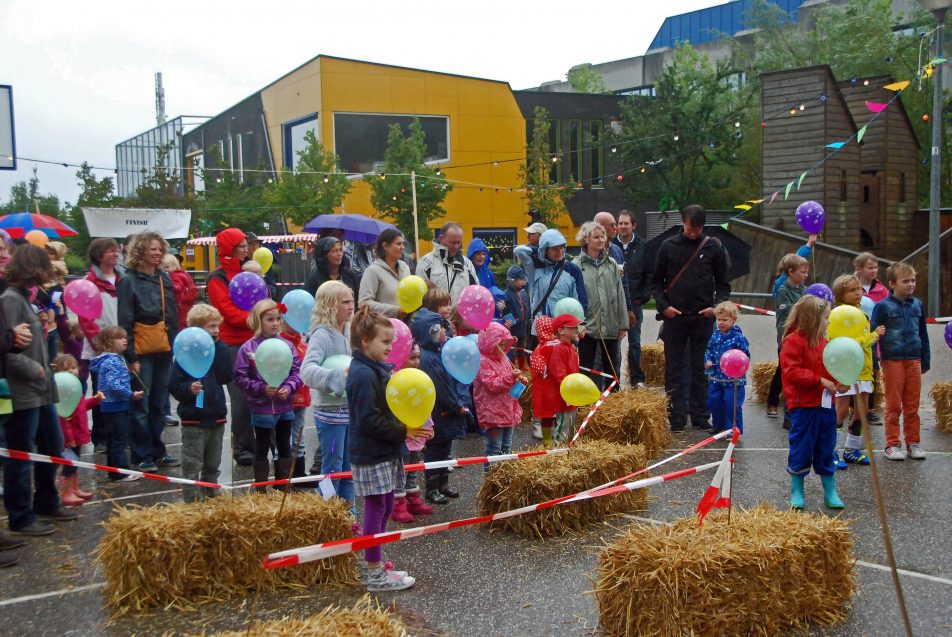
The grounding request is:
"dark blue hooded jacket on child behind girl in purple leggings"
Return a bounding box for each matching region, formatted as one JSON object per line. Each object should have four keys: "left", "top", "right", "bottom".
{"left": 410, "top": 308, "right": 469, "bottom": 440}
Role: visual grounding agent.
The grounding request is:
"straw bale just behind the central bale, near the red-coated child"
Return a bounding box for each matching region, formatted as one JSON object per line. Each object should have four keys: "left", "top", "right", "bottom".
{"left": 582, "top": 387, "right": 671, "bottom": 458}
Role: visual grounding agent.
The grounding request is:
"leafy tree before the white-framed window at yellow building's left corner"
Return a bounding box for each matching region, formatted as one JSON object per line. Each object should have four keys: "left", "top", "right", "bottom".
{"left": 265, "top": 131, "right": 353, "bottom": 225}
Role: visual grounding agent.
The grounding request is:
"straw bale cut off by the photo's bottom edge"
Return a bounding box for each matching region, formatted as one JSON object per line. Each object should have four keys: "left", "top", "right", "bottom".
{"left": 202, "top": 595, "right": 409, "bottom": 637}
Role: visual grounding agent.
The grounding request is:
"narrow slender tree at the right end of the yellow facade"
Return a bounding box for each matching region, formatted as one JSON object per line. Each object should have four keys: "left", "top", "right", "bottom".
{"left": 519, "top": 106, "right": 575, "bottom": 226}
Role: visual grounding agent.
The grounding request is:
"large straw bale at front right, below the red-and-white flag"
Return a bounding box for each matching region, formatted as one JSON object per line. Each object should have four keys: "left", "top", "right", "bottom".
{"left": 594, "top": 505, "right": 856, "bottom": 637}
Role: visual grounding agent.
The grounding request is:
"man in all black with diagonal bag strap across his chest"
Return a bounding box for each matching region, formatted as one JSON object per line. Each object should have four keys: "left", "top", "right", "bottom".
{"left": 651, "top": 204, "right": 731, "bottom": 431}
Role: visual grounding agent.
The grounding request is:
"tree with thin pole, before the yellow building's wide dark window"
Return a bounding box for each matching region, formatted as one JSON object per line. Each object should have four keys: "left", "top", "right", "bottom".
{"left": 364, "top": 117, "right": 453, "bottom": 246}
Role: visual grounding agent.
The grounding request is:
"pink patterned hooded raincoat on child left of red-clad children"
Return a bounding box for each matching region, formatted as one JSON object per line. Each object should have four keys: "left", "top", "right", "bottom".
{"left": 473, "top": 323, "right": 522, "bottom": 429}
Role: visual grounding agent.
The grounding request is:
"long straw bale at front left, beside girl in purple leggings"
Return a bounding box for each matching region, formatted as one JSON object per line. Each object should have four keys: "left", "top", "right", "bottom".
{"left": 97, "top": 493, "right": 357, "bottom": 614}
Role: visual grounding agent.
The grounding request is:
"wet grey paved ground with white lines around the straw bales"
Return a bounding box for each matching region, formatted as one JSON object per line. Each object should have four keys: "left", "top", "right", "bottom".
{"left": 0, "top": 316, "right": 952, "bottom": 637}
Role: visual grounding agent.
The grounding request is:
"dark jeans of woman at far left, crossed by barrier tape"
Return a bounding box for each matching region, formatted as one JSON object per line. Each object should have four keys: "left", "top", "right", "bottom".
{"left": 3, "top": 405, "right": 63, "bottom": 531}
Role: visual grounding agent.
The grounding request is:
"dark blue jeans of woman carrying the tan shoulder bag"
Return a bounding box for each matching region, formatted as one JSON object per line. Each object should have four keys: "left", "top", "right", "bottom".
{"left": 129, "top": 353, "right": 172, "bottom": 464}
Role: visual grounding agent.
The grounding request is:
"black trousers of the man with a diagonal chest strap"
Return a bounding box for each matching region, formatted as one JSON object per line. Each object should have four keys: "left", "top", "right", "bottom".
{"left": 662, "top": 314, "right": 714, "bottom": 429}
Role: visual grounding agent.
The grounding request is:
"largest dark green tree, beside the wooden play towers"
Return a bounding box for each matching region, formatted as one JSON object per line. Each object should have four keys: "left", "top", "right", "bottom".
{"left": 611, "top": 43, "right": 760, "bottom": 210}
